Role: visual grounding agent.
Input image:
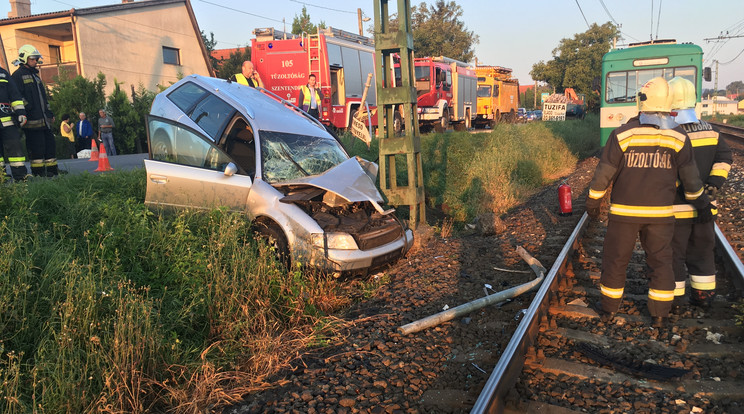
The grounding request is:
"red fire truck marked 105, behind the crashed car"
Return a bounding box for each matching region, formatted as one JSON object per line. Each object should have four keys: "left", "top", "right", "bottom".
{"left": 251, "top": 28, "right": 377, "bottom": 129}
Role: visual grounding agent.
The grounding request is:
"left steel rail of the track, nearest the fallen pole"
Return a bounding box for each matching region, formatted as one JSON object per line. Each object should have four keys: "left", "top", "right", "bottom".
{"left": 470, "top": 213, "right": 589, "bottom": 414}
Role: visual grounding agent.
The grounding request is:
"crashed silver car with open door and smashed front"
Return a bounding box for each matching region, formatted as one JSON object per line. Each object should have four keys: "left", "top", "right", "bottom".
{"left": 145, "top": 75, "right": 413, "bottom": 274}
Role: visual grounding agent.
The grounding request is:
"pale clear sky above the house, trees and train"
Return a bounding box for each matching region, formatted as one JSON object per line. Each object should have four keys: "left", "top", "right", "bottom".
{"left": 0, "top": 0, "right": 744, "bottom": 89}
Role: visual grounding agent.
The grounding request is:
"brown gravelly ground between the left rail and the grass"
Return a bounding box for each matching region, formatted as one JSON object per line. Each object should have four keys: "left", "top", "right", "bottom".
{"left": 226, "top": 158, "right": 597, "bottom": 413}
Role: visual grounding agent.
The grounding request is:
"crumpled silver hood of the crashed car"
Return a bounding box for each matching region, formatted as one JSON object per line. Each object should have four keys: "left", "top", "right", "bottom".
{"left": 273, "top": 158, "right": 383, "bottom": 203}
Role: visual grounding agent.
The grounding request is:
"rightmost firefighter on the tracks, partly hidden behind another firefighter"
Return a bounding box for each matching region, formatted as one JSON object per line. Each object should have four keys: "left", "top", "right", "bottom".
{"left": 669, "top": 77, "right": 733, "bottom": 309}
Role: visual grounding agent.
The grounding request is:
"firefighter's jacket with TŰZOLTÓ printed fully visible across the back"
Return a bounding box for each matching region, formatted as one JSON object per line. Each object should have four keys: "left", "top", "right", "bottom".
{"left": 586, "top": 116, "right": 708, "bottom": 223}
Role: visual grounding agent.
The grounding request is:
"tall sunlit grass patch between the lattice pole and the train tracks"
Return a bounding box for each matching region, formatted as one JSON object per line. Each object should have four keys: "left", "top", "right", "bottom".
{"left": 342, "top": 115, "right": 599, "bottom": 224}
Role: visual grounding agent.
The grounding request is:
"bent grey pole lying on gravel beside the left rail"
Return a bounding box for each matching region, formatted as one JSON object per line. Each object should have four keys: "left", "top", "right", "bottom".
{"left": 398, "top": 246, "right": 546, "bottom": 335}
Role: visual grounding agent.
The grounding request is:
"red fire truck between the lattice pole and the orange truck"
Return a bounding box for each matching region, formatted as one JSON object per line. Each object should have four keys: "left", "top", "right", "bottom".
{"left": 395, "top": 56, "right": 478, "bottom": 131}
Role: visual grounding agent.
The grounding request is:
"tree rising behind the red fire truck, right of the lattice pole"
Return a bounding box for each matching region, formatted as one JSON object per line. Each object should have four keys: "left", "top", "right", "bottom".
{"left": 411, "top": 0, "right": 479, "bottom": 62}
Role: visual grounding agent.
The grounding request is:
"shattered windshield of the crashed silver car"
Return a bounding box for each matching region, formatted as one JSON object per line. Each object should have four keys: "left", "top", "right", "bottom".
{"left": 260, "top": 131, "right": 348, "bottom": 183}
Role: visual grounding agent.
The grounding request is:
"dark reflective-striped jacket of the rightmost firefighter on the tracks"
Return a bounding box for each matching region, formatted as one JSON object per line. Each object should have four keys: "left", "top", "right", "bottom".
{"left": 674, "top": 120, "right": 733, "bottom": 220}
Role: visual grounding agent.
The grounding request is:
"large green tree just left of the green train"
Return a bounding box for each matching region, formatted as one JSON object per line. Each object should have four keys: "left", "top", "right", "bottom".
{"left": 530, "top": 22, "right": 620, "bottom": 111}
